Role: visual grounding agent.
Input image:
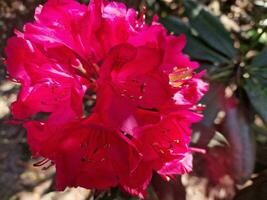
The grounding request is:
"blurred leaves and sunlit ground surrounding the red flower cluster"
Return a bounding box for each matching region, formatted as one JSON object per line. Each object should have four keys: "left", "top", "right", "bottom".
{"left": 0, "top": 0, "right": 267, "bottom": 200}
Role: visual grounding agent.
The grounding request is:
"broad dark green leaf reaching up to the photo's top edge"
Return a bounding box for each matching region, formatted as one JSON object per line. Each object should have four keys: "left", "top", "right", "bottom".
{"left": 184, "top": 0, "right": 236, "bottom": 58}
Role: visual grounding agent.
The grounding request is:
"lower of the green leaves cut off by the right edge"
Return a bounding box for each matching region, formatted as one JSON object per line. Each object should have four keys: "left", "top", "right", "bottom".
{"left": 244, "top": 79, "right": 267, "bottom": 122}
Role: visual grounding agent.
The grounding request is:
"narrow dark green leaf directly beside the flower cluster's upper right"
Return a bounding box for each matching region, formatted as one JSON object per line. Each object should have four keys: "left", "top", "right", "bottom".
{"left": 161, "top": 16, "right": 228, "bottom": 64}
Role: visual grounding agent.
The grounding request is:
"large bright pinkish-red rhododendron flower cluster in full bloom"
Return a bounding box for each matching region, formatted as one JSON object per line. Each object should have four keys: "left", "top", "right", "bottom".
{"left": 5, "top": 0, "right": 207, "bottom": 197}
